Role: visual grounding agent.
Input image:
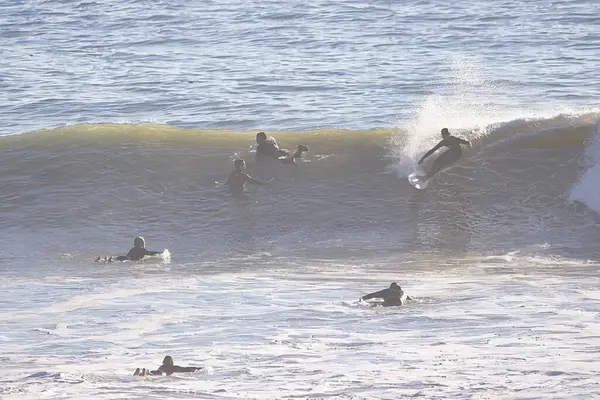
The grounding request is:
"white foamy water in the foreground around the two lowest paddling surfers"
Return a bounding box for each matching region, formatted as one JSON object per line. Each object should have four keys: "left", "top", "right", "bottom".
{"left": 0, "top": 253, "right": 600, "bottom": 399}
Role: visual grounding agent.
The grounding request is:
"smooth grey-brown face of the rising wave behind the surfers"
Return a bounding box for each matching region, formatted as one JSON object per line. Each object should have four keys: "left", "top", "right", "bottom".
{"left": 0, "top": 113, "right": 600, "bottom": 259}
